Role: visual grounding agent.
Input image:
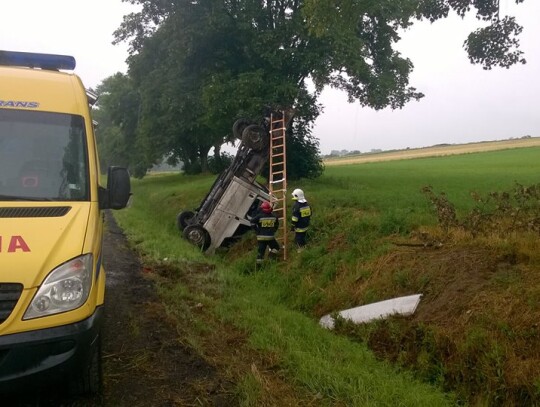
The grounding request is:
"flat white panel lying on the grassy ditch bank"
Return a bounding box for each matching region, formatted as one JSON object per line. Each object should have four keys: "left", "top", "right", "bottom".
{"left": 319, "top": 294, "right": 422, "bottom": 329}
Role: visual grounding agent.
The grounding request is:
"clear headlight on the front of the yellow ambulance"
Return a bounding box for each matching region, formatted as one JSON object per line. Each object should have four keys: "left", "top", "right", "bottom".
{"left": 23, "top": 254, "right": 93, "bottom": 320}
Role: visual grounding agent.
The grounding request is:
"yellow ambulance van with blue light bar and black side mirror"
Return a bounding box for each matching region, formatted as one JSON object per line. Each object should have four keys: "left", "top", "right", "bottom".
{"left": 0, "top": 51, "right": 130, "bottom": 396}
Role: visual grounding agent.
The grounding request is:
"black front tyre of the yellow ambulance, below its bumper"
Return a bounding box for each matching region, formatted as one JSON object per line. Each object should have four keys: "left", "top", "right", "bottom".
{"left": 70, "top": 334, "right": 103, "bottom": 396}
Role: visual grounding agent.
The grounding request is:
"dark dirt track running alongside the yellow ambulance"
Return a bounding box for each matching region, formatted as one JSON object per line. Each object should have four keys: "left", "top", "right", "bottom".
{"left": 6, "top": 213, "right": 238, "bottom": 407}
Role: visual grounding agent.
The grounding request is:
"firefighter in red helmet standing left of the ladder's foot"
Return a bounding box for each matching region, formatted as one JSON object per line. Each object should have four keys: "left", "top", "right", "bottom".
{"left": 251, "top": 201, "right": 279, "bottom": 267}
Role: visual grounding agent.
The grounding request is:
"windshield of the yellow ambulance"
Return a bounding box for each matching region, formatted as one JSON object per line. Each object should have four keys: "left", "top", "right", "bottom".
{"left": 0, "top": 109, "right": 89, "bottom": 201}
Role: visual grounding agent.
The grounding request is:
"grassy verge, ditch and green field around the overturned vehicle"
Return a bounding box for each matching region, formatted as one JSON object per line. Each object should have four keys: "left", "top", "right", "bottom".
{"left": 115, "top": 148, "right": 540, "bottom": 406}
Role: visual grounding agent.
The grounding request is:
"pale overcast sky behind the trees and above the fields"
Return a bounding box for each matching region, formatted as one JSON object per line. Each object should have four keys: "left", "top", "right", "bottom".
{"left": 0, "top": 0, "right": 540, "bottom": 154}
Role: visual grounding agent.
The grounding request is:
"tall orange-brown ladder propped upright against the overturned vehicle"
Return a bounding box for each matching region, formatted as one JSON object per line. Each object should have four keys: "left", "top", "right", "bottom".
{"left": 268, "top": 111, "right": 287, "bottom": 260}
